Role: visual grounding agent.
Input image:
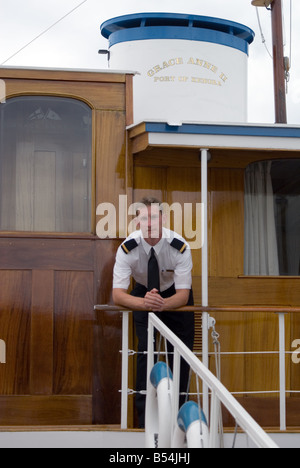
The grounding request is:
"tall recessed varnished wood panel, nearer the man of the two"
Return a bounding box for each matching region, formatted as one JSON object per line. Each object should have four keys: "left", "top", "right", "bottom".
{"left": 53, "top": 271, "right": 94, "bottom": 395}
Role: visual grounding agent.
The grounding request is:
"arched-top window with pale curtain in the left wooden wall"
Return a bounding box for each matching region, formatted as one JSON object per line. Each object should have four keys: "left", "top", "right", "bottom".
{"left": 0, "top": 96, "right": 92, "bottom": 232}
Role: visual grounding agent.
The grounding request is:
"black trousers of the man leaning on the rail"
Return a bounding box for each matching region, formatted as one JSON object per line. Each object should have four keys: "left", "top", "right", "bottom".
{"left": 131, "top": 284, "right": 195, "bottom": 427}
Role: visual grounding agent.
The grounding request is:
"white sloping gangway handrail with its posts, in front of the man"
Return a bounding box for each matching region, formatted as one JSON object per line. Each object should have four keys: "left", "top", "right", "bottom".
{"left": 147, "top": 313, "right": 278, "bottom": 448}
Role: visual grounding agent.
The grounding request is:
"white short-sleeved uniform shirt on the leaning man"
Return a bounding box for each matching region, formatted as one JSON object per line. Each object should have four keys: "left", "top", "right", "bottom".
{"left": 113, "top": 228, "right": 193, "bottom": 292}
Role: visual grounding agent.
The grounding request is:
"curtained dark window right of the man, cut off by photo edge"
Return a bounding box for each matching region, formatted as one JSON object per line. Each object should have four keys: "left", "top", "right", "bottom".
{"left": 245, "top": 159, "right": 300, "bottom": 276}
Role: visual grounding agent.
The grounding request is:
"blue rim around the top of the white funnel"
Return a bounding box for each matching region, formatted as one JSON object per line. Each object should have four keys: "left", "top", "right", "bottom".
{"left": 100, "top": 13, "right": 255, "bottom": 53}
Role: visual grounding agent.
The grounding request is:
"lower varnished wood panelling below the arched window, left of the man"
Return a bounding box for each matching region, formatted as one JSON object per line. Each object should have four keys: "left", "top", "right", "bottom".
{"left": 0, "top": 239, "right": 121, "bottom": 425}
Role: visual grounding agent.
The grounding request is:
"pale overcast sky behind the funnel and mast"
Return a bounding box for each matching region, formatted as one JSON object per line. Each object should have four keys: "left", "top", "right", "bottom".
{"left": 0, "top": 0, "right": 300, "bottom": 125}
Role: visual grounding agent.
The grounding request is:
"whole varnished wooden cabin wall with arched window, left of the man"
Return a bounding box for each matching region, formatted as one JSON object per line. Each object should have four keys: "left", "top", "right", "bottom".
{"left": 0, "top": 71, "right": 131, "bottom": 426}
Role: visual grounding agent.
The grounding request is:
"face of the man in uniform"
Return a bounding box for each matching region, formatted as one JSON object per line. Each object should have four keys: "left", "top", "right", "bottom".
{"left": 138, "top": 205, "right": 162, "bottom": 242}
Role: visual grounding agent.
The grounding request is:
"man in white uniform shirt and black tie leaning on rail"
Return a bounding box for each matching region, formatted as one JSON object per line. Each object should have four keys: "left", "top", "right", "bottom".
{"left": 113, "top": 198, "right": 194, "bottom": 427}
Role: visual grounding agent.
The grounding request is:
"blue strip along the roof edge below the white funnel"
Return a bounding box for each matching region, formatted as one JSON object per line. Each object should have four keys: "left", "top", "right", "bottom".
{"left": 145, "top": 122, "right": 300, "bottom": 138}
